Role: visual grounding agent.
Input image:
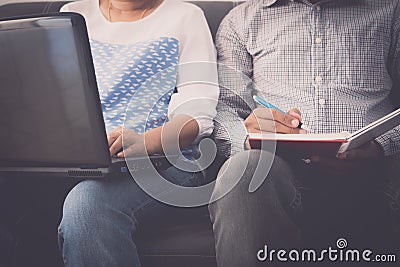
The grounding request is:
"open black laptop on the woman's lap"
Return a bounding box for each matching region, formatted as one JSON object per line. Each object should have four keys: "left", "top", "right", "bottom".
{"left": 0, "top": 13, "right": 177, "bottom": 178}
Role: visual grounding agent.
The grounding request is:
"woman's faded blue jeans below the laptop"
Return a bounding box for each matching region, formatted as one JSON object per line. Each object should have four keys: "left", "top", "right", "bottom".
{"left": 58, "top": 164, "right": 204, "bottom": 267}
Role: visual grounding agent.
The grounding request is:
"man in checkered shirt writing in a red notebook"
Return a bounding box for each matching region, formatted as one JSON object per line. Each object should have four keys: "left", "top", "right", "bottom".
{"left": 210, "top": 0, "right": 400, "bottom": 267}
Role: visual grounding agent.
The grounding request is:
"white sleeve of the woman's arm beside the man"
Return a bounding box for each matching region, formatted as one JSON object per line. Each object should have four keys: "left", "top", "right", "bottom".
{"left": 167, "top": 7, "right": 219, "bottom": 145}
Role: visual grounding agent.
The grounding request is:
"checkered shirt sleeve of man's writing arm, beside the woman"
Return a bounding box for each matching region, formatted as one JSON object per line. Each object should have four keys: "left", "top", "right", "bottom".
{"left": 214, "top": 10, "right": 254, "bottom": 157}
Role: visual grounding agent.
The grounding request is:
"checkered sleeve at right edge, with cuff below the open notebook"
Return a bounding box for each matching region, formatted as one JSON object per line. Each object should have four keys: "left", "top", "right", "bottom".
{"left": 376, "top": 4, "right": 400, "bottom": 156}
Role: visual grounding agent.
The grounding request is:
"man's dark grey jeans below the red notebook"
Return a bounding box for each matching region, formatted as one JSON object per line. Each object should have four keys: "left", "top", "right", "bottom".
{"left": 209, "top": 150, "right": 398, "bottom": 267}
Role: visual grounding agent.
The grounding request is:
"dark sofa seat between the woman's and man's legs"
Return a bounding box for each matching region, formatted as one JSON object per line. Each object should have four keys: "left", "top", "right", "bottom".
{"left": 135, "top": 206, "right": 216, "bottom": 267}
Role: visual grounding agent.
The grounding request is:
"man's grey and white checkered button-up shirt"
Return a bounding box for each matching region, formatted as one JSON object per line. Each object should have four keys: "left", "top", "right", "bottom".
{"left": 214, "top": 0, "right": 400, "bottom": 156}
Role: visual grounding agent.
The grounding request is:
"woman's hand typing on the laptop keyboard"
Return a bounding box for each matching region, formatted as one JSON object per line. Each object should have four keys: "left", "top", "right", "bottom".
{"left": 107, "top": 127, "right": 146, "bottom": 158}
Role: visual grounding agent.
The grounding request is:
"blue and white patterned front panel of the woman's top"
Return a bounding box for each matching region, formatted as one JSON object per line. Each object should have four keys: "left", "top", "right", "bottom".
{"left": 90, "top": 37, "right": 179, "bottom": 133}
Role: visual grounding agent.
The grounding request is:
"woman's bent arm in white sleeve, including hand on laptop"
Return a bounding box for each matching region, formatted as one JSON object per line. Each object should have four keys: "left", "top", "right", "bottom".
{"left": 109, "top": 8, "right": 219, "bottom": 157}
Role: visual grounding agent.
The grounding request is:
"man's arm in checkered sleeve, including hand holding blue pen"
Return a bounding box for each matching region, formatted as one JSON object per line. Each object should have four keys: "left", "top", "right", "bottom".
{"left": 214, "top": 10, "right": 306, "bottom": 157}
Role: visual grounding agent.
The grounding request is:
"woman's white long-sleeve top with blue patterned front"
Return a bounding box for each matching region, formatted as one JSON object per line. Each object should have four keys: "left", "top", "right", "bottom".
{"left": 61, "top": 0, "right": 219, "bottom": 144}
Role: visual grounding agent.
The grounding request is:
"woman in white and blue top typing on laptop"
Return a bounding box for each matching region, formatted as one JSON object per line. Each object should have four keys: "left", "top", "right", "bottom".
{"left": 59, "top": 0, "right": 218, "bottom": 267}
